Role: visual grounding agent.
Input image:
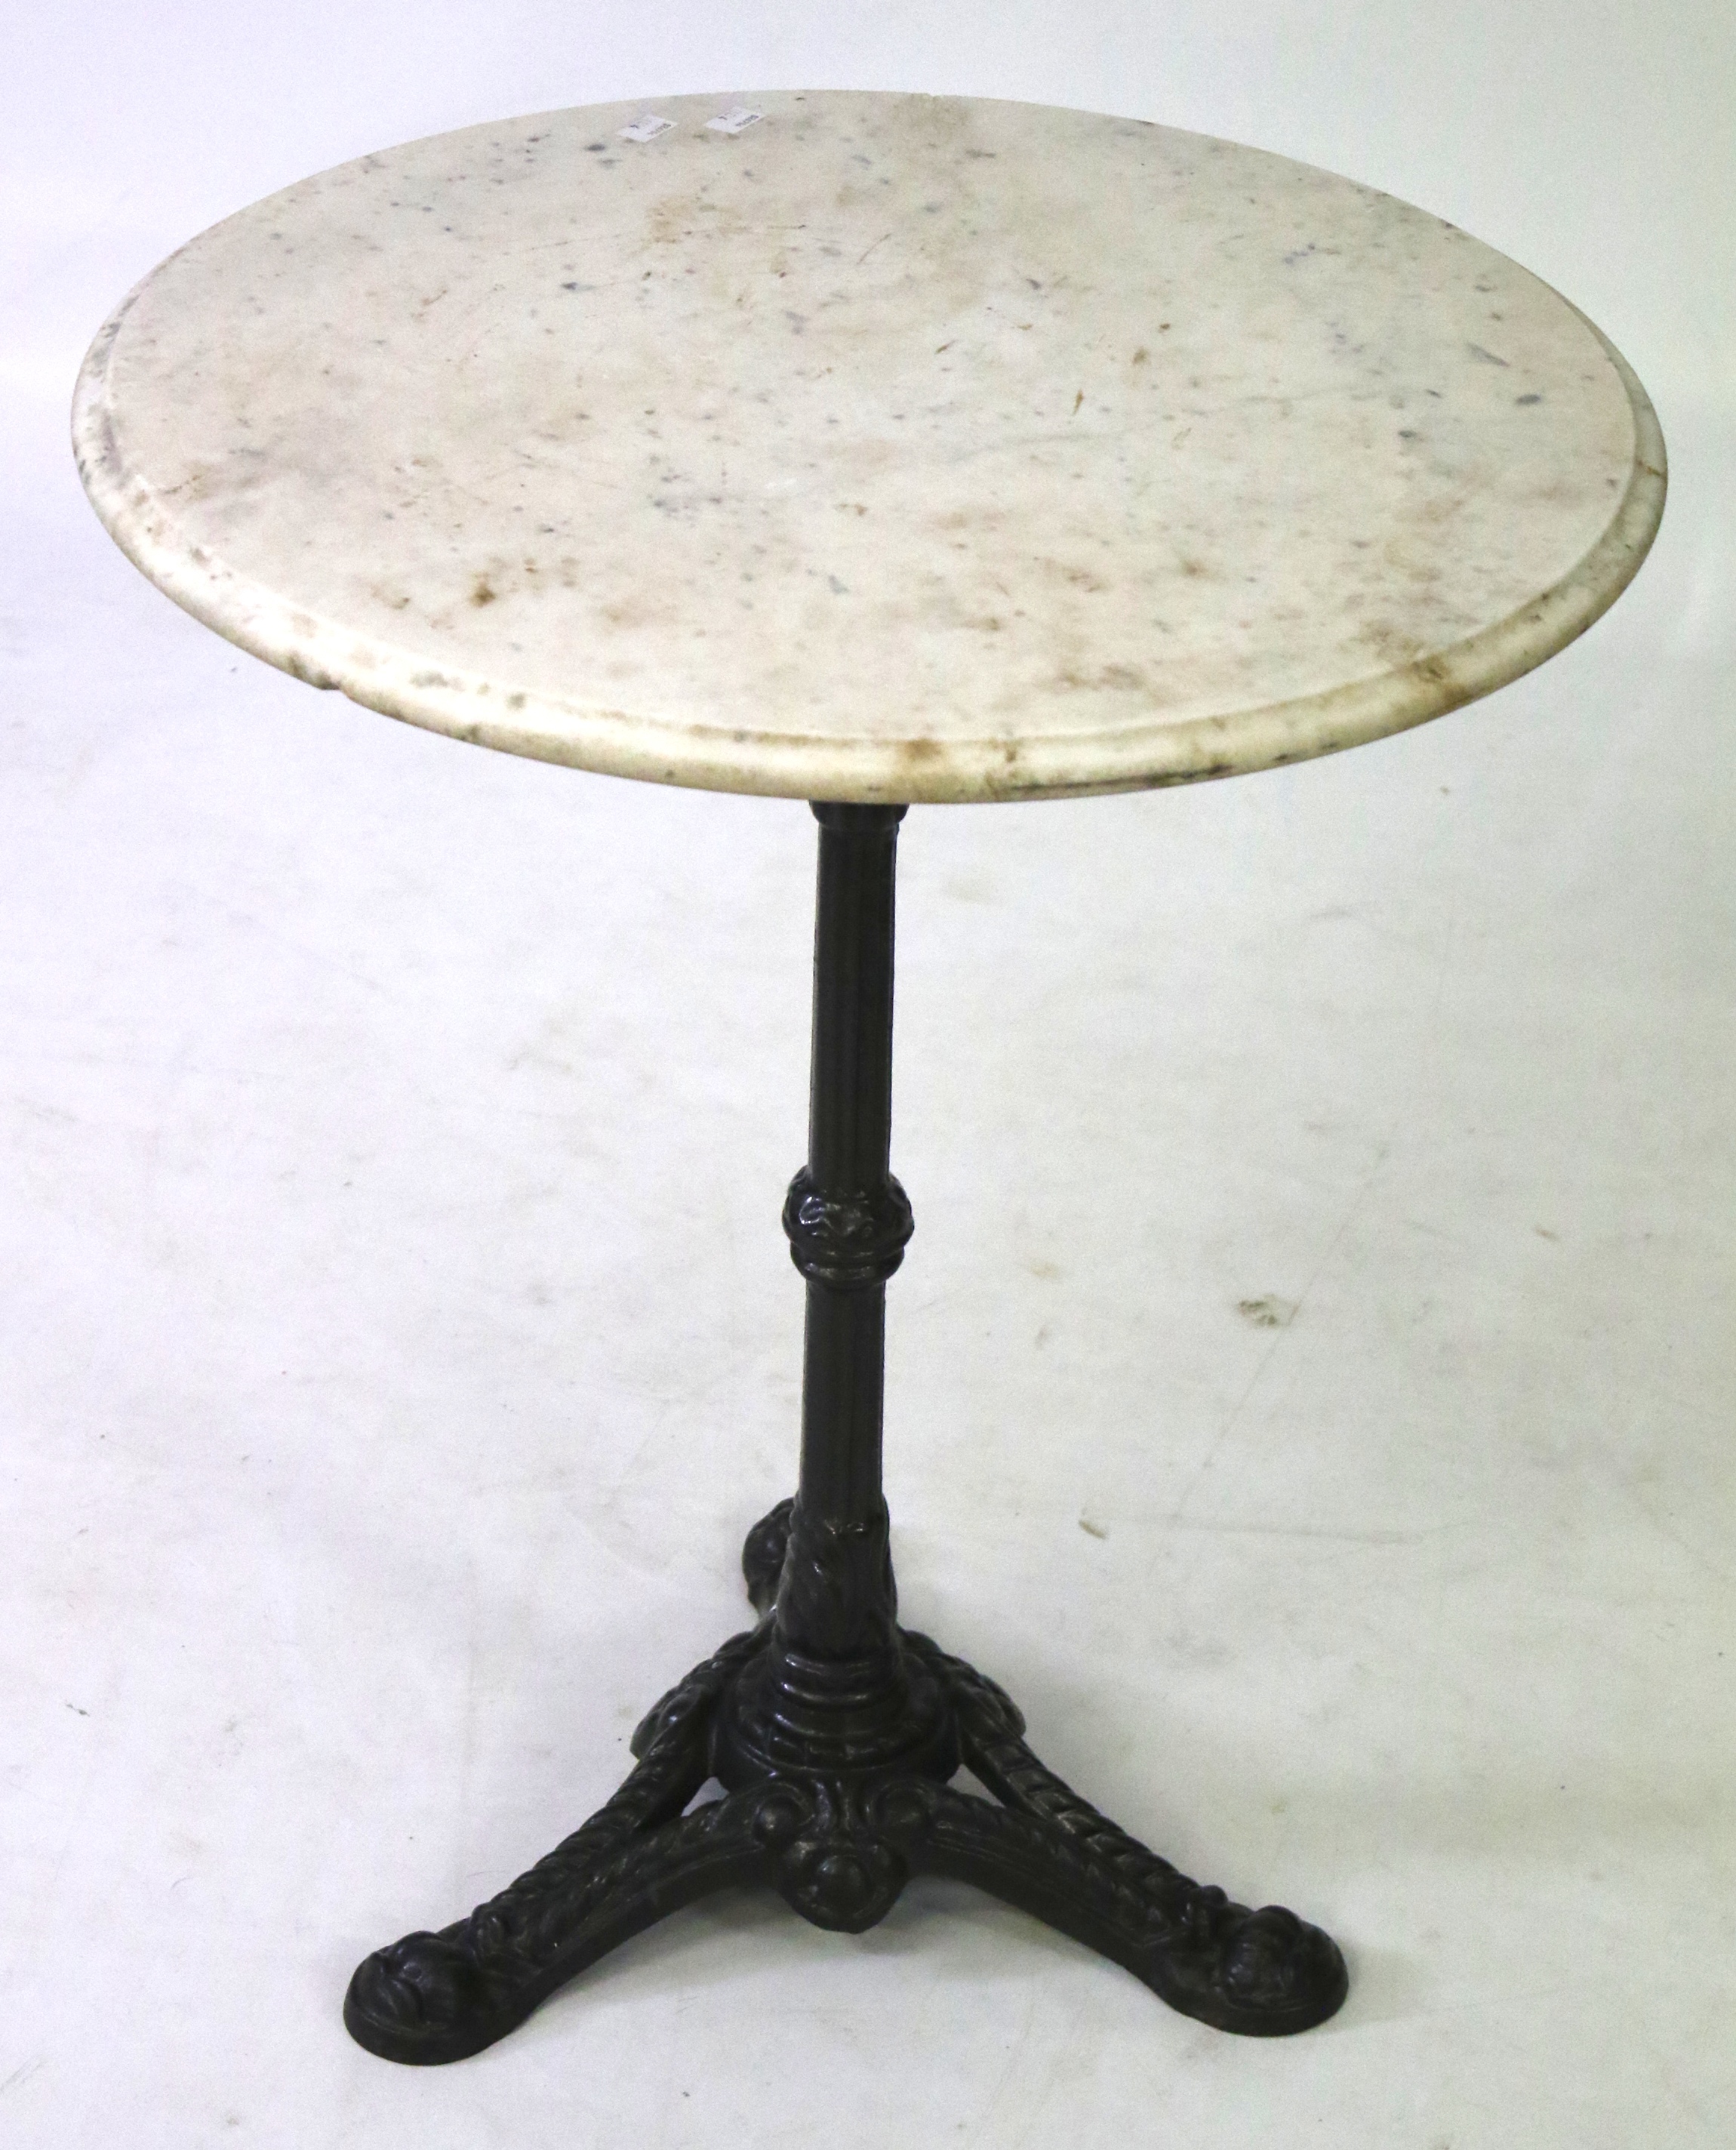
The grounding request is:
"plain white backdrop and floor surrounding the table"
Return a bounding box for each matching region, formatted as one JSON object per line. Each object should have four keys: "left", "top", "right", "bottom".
{"left": 0, "top": 0, "right": 1736, "bottom": 2150}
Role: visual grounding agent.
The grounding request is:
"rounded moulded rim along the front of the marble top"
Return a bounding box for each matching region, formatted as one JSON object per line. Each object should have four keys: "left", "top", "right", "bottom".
{"left": 73, "top": 134, "right": 1667, "bottom": 804}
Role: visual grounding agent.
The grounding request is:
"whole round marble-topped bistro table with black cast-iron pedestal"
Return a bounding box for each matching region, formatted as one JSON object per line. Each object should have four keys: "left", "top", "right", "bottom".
{"left": 73, "top": 92, "right": 1665, "bottom": 2062}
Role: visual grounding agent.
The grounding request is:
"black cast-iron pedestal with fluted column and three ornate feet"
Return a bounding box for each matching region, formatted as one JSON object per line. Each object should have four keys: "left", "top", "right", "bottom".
{"left": 343, "top": 804, "right": 1347, "bottom": 2064}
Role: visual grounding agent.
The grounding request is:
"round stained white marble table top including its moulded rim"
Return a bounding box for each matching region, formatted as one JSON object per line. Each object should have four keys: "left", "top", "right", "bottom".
{"left": 75, "top": 92, "right": 1665, "bottom": 799}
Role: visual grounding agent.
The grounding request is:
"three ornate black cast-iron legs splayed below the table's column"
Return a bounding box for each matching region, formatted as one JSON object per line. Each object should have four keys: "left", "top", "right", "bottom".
{"left": 343, "top": 1501, "right": 1345, "bottom": 2064}
